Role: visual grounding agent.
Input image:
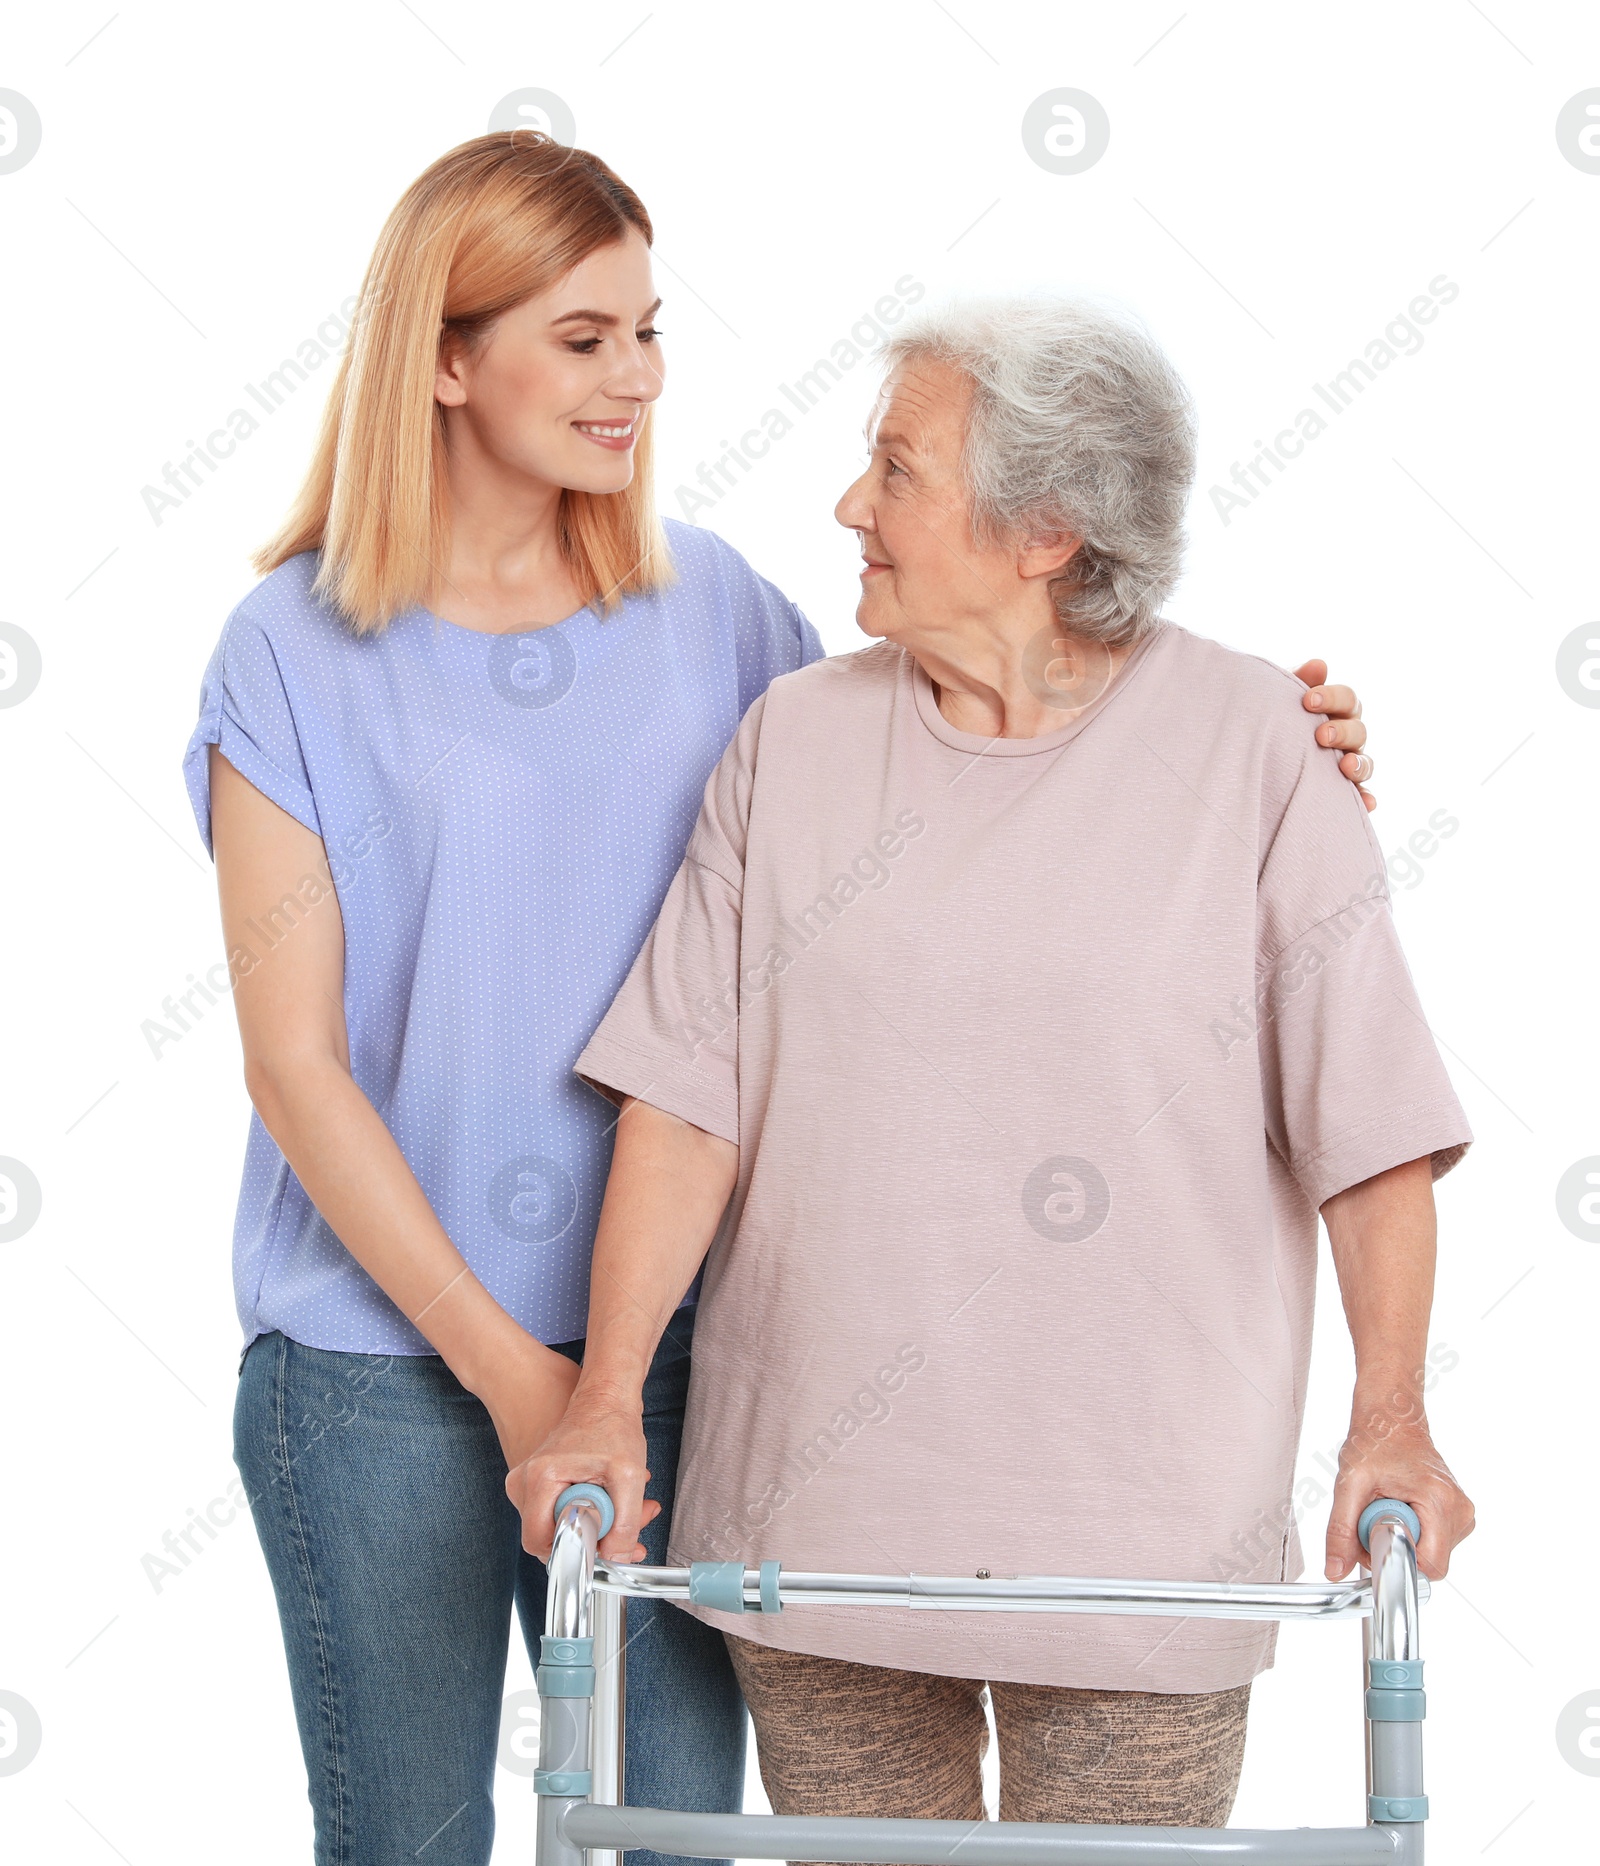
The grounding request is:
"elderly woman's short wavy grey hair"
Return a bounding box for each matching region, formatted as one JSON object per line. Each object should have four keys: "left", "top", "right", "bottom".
{"left": 883, "top": 299, "right": 1195, "bottom": 646}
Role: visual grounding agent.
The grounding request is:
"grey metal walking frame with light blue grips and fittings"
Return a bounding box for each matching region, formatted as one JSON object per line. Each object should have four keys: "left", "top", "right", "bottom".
{"left": 534, "top": 1483, "right": 1428, "bottom": 1866}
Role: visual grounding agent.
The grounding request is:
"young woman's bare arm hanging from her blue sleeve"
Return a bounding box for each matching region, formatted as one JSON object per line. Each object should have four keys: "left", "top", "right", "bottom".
{"left": 211, "top": 746, "right": 577, "bottom": 1465}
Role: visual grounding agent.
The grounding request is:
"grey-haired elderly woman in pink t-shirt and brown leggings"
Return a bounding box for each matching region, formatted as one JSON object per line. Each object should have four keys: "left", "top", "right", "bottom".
{"left": 512, "top": 302, "right": 1471, "bottom": 1825}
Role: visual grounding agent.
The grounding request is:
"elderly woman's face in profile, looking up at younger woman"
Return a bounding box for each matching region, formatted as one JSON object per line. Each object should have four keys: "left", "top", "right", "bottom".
{"left": 833, "top": 360, "right": 1016, "bottom": 648}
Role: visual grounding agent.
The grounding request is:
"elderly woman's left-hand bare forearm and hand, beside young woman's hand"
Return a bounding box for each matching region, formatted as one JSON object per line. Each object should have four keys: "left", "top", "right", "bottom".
{"left": 506, "top": 1099, "right": 739, "bottom": 1562}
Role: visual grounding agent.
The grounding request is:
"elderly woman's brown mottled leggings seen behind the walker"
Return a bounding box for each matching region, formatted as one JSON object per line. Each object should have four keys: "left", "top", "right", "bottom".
{"left": 728, "top": 1638, "right": 1251, "bottom": 1827}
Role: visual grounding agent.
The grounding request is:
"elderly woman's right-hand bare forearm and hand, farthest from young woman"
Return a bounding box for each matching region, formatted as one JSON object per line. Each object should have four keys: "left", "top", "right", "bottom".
{"left": 1322, "top": 1159, "right": 1473, "bottom": 1581}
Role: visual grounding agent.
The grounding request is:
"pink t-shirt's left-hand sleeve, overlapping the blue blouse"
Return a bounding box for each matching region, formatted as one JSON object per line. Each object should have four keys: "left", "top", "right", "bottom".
{"left": 575, "top": 700, "right": 765, "bottom": 1146}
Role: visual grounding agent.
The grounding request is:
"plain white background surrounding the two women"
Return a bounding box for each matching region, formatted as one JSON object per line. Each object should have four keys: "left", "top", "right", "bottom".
{"left": 0, "top": 0, "right": 1600, "bottom": 1866}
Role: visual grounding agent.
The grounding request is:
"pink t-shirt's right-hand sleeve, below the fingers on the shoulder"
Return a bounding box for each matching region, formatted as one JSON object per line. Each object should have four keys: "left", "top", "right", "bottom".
{"left": 1256, "top": 718, "right": 1471, "bottom": 1207}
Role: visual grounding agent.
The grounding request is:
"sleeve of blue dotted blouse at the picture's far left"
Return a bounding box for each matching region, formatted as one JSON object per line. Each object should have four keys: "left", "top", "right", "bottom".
{"left": 183, "top": 610, "right": 323, "bottom": 851}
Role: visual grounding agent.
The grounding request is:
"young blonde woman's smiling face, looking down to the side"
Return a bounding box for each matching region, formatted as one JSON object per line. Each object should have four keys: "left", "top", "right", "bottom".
{"left": 433, "top": 233, "right": 663, "bottom": 493}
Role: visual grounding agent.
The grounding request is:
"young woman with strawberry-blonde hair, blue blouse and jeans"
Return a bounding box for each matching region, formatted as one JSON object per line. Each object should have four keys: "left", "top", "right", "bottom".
{"left": 187, "top": 132, "right": 1370, "bottom": 1866}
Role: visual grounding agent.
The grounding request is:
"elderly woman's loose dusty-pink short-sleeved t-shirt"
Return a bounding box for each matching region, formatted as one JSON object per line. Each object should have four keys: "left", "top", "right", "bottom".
{"left": 577, "top": 625, "right": 1471, "bottom": 1691}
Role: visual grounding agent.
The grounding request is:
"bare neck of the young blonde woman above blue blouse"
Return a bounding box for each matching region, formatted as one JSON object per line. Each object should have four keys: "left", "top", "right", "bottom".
{"left": 437, "top": 409, "right": 584, "bottom": 634}
